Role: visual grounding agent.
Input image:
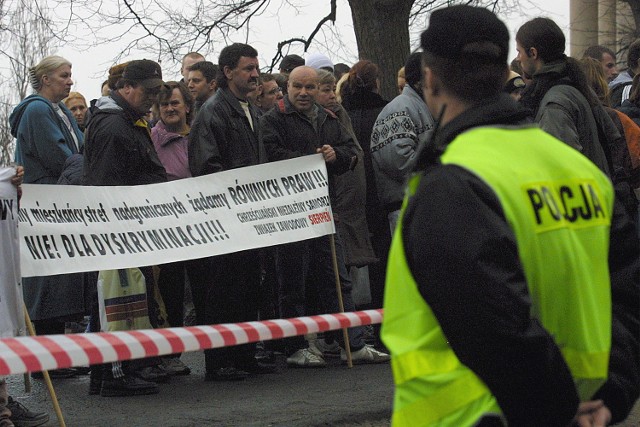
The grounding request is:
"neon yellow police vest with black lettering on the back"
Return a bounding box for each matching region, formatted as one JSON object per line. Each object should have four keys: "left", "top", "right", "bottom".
{"left": 382, "top": 127, "right": 613, "bottom": 426}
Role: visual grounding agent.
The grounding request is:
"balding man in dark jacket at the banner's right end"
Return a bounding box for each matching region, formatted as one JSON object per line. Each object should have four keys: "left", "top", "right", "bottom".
{"left": 260, "top": 66, "right": 389, "bottom": 367}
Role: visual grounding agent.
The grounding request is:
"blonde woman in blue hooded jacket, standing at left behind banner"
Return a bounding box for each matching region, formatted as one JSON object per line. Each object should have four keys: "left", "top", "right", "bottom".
{"left": 9, "top": 56, "right": 87, "bottom": 377}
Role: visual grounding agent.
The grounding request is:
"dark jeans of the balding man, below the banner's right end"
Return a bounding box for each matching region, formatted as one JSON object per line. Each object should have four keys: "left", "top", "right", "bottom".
{"left": 276, "top": 235, "right": 364, "bottom": 355}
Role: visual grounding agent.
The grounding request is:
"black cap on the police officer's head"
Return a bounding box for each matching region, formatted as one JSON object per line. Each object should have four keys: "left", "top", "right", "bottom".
{"left": 421, "top": 5, "right": 509, "bottom": 64}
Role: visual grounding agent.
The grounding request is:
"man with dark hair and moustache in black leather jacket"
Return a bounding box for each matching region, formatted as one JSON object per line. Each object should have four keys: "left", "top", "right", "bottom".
{"left": 189, "top": 43, "right": 274, "bottom": 381}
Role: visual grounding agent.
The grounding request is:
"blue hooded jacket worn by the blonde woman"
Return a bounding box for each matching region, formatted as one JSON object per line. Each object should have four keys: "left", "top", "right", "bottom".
{"left": 9, "top": 94, "right": 83, "bottom": 184}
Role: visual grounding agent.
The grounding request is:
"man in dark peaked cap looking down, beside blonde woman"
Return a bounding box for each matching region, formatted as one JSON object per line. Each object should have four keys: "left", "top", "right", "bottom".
{"left": 83, "top": 59, "right": 167, "bottom": 396}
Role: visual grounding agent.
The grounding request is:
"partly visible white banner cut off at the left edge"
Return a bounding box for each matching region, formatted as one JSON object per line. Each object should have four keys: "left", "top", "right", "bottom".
{"left": 0, "top": 167, "right": 25, "bottom": 338}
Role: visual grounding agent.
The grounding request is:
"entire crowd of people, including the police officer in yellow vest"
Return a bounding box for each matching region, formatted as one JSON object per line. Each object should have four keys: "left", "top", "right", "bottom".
{"left": 0, "top": 6, "right": 640, "bottom": 427}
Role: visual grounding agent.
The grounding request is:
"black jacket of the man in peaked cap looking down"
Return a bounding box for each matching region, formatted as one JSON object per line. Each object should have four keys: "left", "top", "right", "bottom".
{"left": 83, "top": 91, "right": 167, "bottom": 185}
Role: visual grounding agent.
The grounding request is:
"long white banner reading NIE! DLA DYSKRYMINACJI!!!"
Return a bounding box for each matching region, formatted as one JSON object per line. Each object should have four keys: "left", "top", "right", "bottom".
{"left": 20, "top": 154, "right": 335, "bottom": 277}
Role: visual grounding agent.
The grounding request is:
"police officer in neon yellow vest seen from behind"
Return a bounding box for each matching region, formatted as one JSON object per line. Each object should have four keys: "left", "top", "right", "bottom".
{"left": 382, "top": 6, "right": 640, "bottom": 427}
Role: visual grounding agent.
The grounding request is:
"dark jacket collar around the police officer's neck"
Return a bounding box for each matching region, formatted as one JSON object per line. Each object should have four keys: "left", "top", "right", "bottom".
{"left": 416, "top": 93, "right": 531, "bottom": 170}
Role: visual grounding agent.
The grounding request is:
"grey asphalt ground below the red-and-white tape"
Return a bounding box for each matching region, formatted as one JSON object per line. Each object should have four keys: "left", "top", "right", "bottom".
{"left": 9, "top": 352, "right": 640, "bottom": 427}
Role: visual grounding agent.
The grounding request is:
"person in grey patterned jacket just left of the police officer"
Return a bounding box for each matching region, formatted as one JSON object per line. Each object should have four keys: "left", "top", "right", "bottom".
{"left": 371, "top": 52, "right": 434, "bottom": 234}
